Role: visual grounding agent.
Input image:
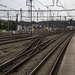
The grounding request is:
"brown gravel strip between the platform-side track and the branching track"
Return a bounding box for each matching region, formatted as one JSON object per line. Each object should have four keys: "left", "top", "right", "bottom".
{"left": 10, "top": 31, "right": 72, "bottom": 75}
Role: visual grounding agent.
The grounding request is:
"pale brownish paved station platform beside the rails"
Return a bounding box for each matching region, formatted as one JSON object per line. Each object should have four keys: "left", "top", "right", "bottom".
{"left": 57, "top": 34, "right": 75, "bottom": 75}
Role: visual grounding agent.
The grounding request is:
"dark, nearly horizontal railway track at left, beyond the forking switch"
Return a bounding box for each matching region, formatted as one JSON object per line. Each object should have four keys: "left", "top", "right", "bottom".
{"left": 0, "top": 33, "right": 52, "bottom": 45}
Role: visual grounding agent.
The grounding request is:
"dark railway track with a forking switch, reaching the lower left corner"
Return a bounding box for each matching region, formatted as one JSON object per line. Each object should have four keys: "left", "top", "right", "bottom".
{"left": 0, "top": 31, "right": 67, "bottom": 74}
